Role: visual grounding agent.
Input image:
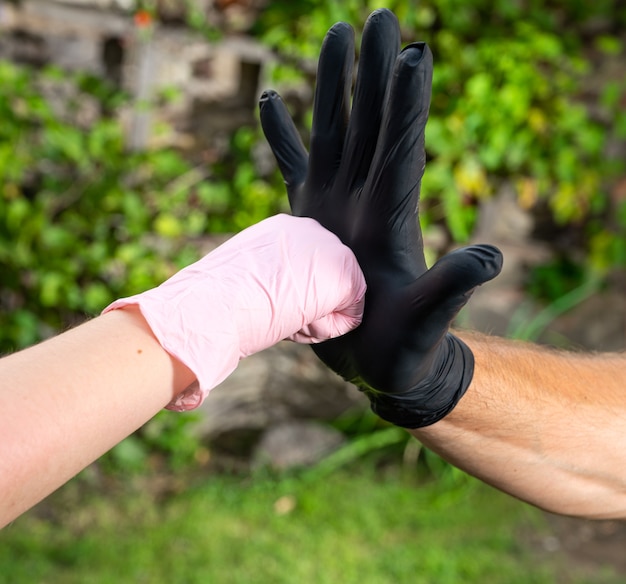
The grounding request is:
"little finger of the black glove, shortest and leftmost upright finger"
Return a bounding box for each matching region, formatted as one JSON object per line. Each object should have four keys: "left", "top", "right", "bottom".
{"left": 259, "top": 86, "right": 309, "bottom": 205}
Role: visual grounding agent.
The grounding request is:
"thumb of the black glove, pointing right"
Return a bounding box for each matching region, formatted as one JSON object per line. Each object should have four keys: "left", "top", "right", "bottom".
{"left": 407, "top": 245, "right": 502, "bottom": 346}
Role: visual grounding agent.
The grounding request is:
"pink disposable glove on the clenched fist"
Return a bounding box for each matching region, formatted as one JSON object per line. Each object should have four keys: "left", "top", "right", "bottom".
{"left": 103, "top": 215, "right": 365, "bottom": 411}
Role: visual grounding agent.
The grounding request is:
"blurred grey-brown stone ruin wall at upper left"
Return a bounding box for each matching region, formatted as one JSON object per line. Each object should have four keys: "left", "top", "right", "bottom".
{"left": 0, "top": 0, "right": 270, "bottom": 149}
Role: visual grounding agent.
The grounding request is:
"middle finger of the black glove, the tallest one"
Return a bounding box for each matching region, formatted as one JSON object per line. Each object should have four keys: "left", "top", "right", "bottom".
{"left": 340, "top": 9, "right": 400, "bottom": 191}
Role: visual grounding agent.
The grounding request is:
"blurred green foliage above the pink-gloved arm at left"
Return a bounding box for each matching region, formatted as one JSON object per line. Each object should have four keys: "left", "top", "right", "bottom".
{"left": 0, "top": 62, "right": 284, "bottom": 353}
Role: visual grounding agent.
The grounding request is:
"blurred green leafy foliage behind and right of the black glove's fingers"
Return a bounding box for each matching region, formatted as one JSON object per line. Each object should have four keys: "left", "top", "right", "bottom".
{"left": 257, "top": 0, "right": 626, "bottom": 268}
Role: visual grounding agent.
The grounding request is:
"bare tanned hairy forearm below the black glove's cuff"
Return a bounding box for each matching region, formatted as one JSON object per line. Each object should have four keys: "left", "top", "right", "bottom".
{"left": 411, "top": 334, "right": 626, "bottom": 519}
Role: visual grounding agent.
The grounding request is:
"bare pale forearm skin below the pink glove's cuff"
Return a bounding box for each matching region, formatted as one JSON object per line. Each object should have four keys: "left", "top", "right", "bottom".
{"left": 0, "top": 307, "right": 195, "bottom": 527}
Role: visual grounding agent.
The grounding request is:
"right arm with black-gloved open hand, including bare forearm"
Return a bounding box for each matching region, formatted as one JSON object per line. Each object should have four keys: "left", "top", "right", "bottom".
{"left": 261, "top": 10, "right": 626, "bottom": 517}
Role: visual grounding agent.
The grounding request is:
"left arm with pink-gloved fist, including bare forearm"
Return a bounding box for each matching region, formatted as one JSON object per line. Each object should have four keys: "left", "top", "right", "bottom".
{"left": 0, "top": 215, "right": 365, "bottom": 526}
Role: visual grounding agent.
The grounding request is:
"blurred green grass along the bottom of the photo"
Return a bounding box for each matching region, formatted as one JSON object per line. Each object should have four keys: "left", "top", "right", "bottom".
{"left": 0, "top": 469, "right": 616, "bottom": 584}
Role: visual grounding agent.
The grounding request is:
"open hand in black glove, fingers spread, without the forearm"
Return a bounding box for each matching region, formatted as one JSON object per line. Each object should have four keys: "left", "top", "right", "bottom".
{"left": 260, "top": 10, "right": 502, "bottom": 428}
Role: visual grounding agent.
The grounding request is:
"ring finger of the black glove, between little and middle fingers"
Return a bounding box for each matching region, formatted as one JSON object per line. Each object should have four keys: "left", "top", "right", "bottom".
{"left": 307, "top": 22, "right": 354, "bottom": 192}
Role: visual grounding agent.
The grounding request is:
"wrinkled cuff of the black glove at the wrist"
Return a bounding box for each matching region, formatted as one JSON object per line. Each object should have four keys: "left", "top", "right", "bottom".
{"left": 365, "top": 334, "right": 474, "bottom": 429}
